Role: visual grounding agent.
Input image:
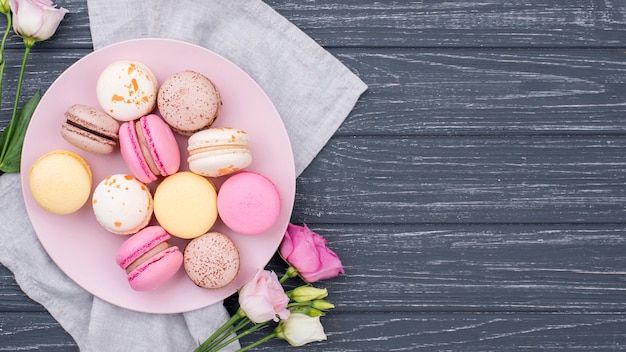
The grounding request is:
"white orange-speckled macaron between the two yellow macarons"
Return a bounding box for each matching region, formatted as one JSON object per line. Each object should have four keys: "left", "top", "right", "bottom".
{"left": 92, "top": 174, "right": 154, "bottom": 235}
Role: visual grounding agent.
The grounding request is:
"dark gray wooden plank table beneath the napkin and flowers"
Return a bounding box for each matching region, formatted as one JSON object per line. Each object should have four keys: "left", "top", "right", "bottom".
{"left": 0, "top": 0, "right": 626, "bottom": 351}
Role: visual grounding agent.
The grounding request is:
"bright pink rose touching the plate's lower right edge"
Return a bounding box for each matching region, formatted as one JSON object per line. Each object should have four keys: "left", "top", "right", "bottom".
{"left": 280, "top": 224, "right": 345, "bottom": 282}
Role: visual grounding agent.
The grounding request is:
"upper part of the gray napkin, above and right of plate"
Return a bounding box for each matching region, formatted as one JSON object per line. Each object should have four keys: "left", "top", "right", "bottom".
{"left": 89, "top": 0, "right": 367, "bottom": 175}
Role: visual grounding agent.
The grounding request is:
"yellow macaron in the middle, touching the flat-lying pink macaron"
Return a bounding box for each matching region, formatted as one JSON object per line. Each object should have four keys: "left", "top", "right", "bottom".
{"left": 154, "top": 171, "right": 217, "bottom": 239}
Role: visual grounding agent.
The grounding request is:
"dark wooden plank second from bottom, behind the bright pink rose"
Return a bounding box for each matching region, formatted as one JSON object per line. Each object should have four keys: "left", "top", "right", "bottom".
{"left": 6, "top": 223, "right": 626, "bottom": 316}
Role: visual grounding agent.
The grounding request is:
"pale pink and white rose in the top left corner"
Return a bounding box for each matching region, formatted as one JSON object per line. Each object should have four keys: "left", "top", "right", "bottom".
{"left": 9, "top": 0, "right": 67, "bottom": 42}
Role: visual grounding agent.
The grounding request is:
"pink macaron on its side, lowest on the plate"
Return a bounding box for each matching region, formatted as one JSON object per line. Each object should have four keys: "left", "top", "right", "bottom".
{"left": 115, "top": 226, "right": 183, "bottom": 291}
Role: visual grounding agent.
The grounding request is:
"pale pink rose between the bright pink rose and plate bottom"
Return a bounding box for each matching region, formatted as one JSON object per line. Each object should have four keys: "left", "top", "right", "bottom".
{"left": 239, "top": 270, "right": 289, "bottom": 323}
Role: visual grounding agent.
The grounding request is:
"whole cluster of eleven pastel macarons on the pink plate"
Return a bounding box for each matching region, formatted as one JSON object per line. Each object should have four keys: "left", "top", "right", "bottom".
{"left": 30, "top": 60, "right": 281, "bottom": 291}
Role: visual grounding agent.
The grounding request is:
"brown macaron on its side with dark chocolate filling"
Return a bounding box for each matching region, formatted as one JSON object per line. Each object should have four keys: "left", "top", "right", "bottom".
{"left": 61, "top": 104, "right": 120, "bottom": 154}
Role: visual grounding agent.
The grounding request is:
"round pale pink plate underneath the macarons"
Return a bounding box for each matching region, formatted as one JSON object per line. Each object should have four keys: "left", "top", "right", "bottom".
{"left": 22, "top": 39, "right": 295, "bottom": 313}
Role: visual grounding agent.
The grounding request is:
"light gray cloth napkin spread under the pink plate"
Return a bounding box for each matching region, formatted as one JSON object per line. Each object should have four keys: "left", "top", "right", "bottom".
{"left": 0, "top": 0, "right": 367, "bottom": 351}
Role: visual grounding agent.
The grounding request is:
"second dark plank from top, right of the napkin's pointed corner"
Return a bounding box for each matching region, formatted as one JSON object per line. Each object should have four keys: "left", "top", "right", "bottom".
{"left": 331, "top": 49, "right": 626, "bottom": 136}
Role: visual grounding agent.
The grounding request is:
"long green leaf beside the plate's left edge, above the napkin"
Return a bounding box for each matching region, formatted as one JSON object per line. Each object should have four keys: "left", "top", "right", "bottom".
{"left": 0, "top": 91, "right": 41, "bottom": 173}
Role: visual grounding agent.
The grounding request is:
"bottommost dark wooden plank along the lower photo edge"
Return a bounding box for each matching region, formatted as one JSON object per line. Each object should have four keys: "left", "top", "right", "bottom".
{"left": 0, "top": 313, "right": 626, "bottom": 352}
